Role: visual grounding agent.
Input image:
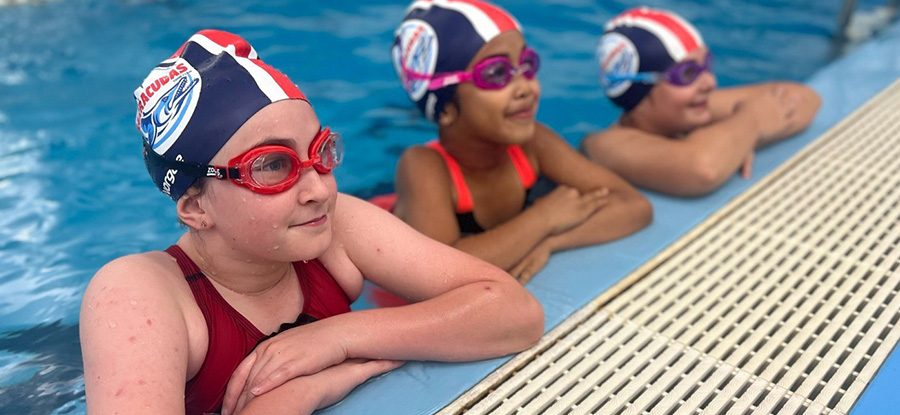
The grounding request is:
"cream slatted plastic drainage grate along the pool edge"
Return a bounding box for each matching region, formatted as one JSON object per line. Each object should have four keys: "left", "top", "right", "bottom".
{"left": 440, "top": 81, "right": 900, "bottom": 415}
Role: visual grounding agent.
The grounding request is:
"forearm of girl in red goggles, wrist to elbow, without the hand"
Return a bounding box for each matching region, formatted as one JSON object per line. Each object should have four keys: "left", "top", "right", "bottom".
{"left": 334, "top": 278, "right": 543, "bottom": 361}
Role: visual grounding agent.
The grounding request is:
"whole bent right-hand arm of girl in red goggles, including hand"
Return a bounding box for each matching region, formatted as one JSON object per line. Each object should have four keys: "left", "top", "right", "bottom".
{"left": 220, "top": 195, "right": 544, "bottom": 410}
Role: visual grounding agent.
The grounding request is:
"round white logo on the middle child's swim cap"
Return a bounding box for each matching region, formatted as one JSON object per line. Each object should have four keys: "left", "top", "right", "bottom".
{"left": 391, "top": 20, "right": 438, "bottom": 101}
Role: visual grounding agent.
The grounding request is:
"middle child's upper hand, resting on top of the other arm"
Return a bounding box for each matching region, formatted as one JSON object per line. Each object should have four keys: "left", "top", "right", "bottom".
{"left": 531, "top": 185, "right": 609, "bottom": 235}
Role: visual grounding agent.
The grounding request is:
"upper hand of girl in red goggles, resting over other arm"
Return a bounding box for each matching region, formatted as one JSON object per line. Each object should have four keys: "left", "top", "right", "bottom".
{"left": 222, "top": 322, "right": 348, "bottom": 415}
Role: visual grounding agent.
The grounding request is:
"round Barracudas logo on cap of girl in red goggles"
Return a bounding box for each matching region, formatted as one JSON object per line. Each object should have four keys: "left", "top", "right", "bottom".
{"left": 134, "top": 58, "right": 201, "bottom": 153}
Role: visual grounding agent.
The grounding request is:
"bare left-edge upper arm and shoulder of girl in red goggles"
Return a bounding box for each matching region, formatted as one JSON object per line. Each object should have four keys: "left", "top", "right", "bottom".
{"left": 79, "top": 254, "right": 189, "bottom": 415}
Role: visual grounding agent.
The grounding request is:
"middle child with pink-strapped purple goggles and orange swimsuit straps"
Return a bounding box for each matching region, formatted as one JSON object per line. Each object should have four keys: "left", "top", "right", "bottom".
{"left": 392, "top": 0, "right": 652, "bottom": 283}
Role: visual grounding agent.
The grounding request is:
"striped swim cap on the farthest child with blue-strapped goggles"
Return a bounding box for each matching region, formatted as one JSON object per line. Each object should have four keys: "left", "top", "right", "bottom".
{"left": 597, "top": 7, "right": 703, "bottom": 112}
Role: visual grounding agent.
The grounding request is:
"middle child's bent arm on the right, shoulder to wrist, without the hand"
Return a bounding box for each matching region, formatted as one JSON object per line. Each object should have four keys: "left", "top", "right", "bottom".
{"left": 532, "top": 124, "right": 653, "bottom": 252}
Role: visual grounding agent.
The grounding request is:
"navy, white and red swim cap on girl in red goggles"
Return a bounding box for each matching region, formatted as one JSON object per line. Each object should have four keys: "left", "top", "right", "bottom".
{"left": 134, "top": 30, "right": 306, "bottom": 200}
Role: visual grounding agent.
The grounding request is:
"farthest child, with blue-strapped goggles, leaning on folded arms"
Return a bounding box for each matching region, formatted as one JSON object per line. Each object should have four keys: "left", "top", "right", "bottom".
{"left": 582, "top": 7, "right": 820, "bottom": 196}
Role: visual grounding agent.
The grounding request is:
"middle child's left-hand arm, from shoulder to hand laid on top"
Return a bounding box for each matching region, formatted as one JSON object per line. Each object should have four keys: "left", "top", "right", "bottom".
{"left": 394, "top": 147, "right": 606, "bottom": 270}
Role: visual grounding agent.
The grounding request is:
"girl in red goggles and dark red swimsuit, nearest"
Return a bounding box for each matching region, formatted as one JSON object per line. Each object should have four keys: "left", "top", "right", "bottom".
{"left": 80, "top": 30, "right": 543, "bottom": 415}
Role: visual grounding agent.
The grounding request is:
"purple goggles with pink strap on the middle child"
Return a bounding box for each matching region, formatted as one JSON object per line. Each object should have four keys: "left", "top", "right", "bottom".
{"left": 403, "top": 48, "right": 541, "bottom": 91}
